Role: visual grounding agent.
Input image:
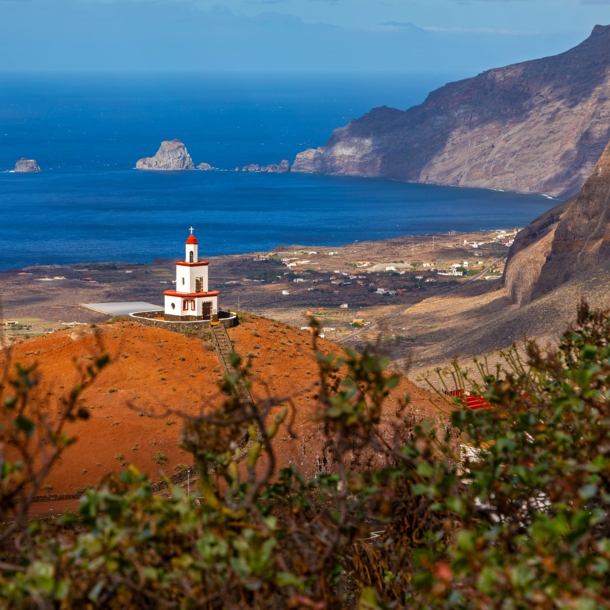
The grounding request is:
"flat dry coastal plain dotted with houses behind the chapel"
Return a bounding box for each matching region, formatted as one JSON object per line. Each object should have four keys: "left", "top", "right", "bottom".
{"left": 0, "top": 228, "right": 515, "bottom": 340}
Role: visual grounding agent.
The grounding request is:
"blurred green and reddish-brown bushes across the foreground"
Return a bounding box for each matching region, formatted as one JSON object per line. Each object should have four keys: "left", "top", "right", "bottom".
{"left": 0, "top": 305, "right": 610, "bottom": 610}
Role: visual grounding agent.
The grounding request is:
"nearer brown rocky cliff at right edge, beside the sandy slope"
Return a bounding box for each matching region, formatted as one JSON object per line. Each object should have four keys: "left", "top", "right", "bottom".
{"left": 504, "top": 135, "right": 610, "bottom": 304}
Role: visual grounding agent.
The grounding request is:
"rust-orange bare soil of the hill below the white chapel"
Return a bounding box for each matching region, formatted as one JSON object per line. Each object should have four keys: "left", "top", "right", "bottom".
{"left": 0, "top": 316, "right": 435, "bottom": 494}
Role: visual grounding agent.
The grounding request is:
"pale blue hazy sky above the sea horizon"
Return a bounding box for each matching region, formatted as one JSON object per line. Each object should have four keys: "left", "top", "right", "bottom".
{"left": 0, "top": 0, "right": 610, "bottom": 75}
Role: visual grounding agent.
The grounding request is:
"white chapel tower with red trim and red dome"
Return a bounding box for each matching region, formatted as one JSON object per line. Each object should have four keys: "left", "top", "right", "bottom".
{"left": 163, "top": 227, "right": 220, "bottom": 322}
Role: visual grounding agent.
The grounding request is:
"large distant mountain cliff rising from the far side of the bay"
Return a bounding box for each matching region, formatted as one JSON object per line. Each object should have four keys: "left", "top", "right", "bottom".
{"left": 292, "top": 26, "right": 610, "bottom": 196}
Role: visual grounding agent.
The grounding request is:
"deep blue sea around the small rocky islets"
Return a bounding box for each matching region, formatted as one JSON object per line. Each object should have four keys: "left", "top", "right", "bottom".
{"left": 0, "top": 74, "right": 555, "bottom": 269}
